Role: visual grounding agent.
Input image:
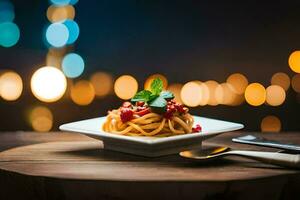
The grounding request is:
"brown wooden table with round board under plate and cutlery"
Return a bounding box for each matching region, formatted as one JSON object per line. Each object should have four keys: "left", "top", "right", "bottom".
{"left": 0, "top": 132, "right": 300, "bottom": 200}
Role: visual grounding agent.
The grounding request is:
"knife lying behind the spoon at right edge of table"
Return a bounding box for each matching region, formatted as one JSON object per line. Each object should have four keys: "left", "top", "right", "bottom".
{"left": 232, "top": 135, "right": 300, "bottom": 153}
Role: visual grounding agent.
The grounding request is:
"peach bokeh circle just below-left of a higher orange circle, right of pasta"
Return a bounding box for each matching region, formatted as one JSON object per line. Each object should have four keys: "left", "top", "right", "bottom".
{"left": 215, "top": 83, "right": 237, "bottom": 105}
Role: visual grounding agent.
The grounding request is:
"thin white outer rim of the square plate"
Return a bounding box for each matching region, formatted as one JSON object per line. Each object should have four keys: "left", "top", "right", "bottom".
{"left": 59, "top": 115, "right": 244, "bottom": 145}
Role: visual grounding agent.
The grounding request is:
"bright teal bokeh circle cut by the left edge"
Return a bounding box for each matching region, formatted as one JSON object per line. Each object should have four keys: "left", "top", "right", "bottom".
{"left": 0, "top": 22, "right": 20, "bottom": 47}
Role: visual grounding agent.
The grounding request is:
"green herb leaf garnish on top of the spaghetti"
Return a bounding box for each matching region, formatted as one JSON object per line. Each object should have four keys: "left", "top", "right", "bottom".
{"left": 131, "top": 78, "right": 174, "bottom": 113}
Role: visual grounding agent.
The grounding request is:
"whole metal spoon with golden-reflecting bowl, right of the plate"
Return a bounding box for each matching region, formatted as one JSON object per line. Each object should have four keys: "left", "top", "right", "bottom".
{"left": 179, "top": 147, "right": 300, "bottom": 168}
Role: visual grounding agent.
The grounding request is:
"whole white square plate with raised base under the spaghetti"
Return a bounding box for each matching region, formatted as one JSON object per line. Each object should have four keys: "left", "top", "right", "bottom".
{"left": 59, "top": 116, "right": 244, "bottom": 157}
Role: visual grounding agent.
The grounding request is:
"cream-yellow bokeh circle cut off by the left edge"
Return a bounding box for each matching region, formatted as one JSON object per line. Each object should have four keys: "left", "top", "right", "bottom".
{"left": 0, "top": 71, "right": 23, "bottom": 101}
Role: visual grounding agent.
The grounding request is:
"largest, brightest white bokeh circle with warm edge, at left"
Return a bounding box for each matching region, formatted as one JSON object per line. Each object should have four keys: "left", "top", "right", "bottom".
{"left": 31, "top": 66, "right": 67, "bottom": 102}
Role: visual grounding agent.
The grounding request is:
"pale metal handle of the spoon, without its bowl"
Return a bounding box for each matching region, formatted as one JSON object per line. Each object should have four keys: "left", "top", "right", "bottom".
{"left": 224, "top": 150, "right": 300, "bottom": 168}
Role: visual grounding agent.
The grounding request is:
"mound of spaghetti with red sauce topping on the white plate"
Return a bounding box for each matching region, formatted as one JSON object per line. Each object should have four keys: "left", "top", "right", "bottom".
{"left": 103, "top": 77, "right": 201, "bottom": 137}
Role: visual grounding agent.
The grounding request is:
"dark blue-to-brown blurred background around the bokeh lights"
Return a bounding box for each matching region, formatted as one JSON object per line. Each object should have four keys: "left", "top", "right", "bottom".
{"left": 0, "top": 0, "right": 300, "bottom": 131}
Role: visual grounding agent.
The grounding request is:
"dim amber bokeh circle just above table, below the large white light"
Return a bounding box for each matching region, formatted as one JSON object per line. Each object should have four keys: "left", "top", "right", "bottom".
{"left": 29, "top": 106, "right": 53, "bottom": 132}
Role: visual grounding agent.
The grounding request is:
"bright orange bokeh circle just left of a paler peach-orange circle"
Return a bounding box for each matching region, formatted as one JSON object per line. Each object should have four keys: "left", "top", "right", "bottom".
{"left": 245, "top": 83, "right": 266, "bottom": 106}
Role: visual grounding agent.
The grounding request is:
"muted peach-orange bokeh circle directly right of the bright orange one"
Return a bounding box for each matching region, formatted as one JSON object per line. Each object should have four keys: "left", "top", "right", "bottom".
{"left": 266, "top": 85, "right": 286, "bottom": 106}
